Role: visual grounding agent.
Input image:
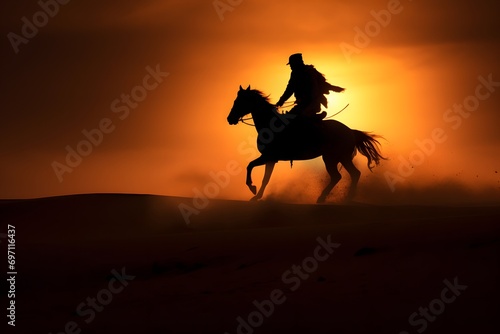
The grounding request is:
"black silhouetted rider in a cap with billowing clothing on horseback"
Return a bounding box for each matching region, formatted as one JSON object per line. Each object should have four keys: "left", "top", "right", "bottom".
{"left": 276, "top": 53, "right": 345, "bottom": 120}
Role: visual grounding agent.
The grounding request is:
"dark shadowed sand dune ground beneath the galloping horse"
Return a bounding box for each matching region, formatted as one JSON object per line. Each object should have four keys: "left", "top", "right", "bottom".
{"left": 0, "top": 194, "right": 500, "bottom": 334}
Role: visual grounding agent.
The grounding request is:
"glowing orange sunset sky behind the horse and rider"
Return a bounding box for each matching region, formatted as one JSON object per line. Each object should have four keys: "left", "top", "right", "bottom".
{"left": 0, "top": 0, "right": 500, "bottom": 201}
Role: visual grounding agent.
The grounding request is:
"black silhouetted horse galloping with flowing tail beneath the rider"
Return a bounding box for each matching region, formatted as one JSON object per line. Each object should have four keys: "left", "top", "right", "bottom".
{"left": 227, "top": 86, "right": 385, "bottom": 203}
